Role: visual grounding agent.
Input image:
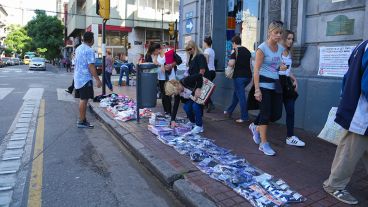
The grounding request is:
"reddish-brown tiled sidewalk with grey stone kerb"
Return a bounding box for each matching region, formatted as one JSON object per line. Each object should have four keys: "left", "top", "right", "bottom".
{"left": 91, "top": 86, "right": 368, "bottom": 206}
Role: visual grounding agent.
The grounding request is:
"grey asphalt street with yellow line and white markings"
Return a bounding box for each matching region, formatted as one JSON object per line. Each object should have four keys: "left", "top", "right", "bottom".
{"left": 0, "top": 65, "right": 181, "bottom": 207}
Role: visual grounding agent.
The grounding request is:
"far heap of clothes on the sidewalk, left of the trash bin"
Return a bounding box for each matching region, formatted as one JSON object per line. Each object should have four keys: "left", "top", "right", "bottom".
{"left": 98, "top": 93, "right": 152, "bottom": 122}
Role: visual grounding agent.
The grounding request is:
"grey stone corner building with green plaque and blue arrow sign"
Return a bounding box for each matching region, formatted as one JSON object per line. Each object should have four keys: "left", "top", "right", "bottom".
{"left": 179, "top": 0, "right": 368, "bottom": 132}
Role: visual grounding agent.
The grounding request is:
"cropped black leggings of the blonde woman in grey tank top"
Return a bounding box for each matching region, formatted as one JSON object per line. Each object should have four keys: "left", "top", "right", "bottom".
{"left": 254, "top": 88, "right": 282, "bottom": 125}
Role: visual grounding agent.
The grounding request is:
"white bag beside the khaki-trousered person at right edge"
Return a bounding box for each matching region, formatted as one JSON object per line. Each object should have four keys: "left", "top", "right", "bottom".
{"left": 318, "top": 107, "right": 348, "bottom": 145}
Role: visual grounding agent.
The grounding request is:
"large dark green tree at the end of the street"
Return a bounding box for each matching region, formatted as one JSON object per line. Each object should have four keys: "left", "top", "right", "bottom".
{"left": 26, "top": 10, "right": 64, "bottom": 60}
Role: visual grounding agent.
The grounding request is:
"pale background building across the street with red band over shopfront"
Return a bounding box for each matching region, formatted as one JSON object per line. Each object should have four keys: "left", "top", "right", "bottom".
{"left": 67, "top": 0, "right": 179, "bottom": 62}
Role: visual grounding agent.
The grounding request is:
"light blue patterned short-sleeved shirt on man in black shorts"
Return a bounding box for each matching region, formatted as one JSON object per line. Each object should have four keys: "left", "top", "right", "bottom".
{"left": 74, "top": 43, "right": 95, "bottom": 89}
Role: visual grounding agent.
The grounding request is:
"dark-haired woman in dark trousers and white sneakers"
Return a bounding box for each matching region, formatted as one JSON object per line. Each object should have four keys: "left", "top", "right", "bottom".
{"left": 279, "top": 30, "right": 305, "bottom": 147}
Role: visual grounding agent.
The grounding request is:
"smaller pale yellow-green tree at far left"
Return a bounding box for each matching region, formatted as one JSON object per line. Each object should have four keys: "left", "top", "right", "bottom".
{"left": 4, "top": 25, "right": 32, "bottom": 54}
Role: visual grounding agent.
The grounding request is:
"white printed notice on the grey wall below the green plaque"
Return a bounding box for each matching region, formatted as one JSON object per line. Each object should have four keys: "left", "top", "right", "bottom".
{"left": 318, "top": 46, "right": 355, "bottom": 77}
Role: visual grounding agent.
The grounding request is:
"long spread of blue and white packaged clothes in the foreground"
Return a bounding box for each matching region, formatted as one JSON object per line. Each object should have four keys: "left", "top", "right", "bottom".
{"left": 158, "top": 133, "right": 306, "bottom": 207}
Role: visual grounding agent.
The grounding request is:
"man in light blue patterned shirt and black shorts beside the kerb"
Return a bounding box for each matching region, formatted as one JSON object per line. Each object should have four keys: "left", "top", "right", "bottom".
{"left": 74, "top": 32, "right": 102, "bottom": 128}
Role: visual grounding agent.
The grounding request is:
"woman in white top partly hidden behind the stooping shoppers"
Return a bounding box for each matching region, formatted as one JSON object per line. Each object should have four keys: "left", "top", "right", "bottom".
{"left": 203, "top": 36, "right": 216, "bottom": 113}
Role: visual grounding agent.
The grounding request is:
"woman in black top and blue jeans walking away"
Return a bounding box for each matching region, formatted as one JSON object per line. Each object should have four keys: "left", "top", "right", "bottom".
{"left": 224, "top": 36, "right": 252, "bottom": 123}
